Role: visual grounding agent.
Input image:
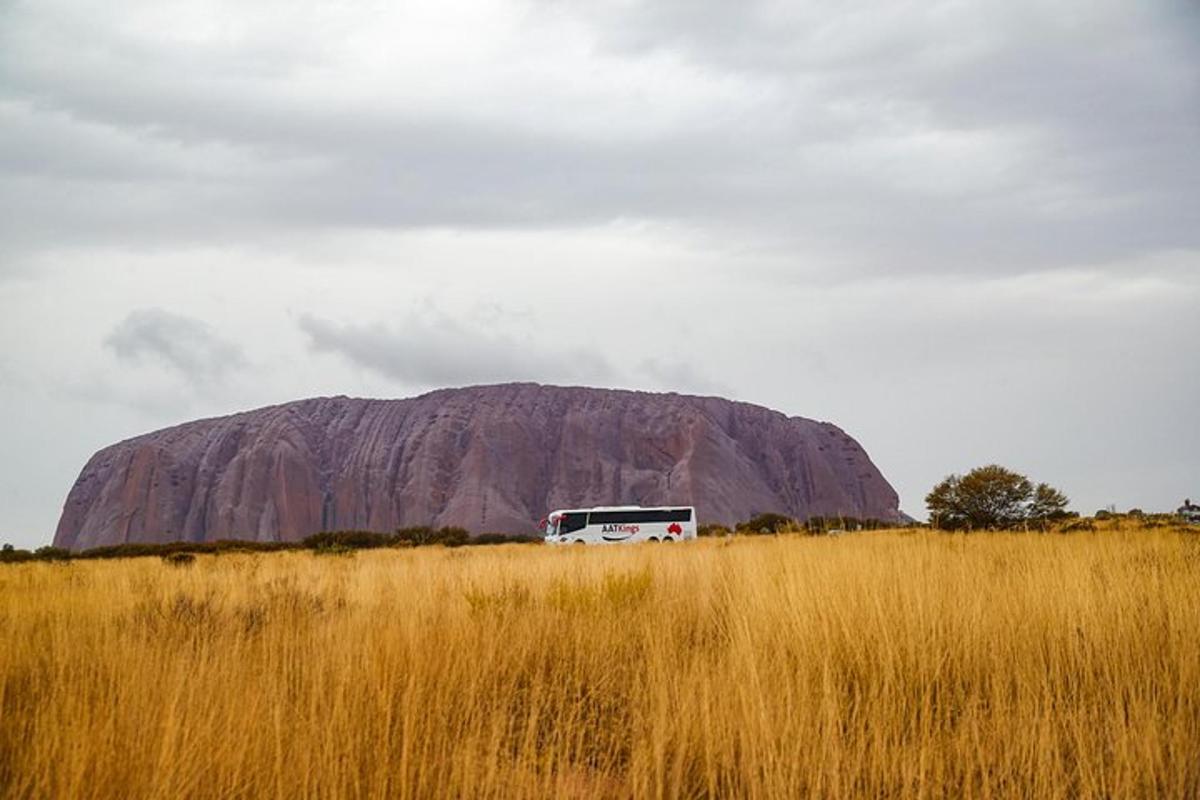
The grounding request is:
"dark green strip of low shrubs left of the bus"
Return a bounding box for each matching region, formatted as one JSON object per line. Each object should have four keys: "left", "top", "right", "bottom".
{"left": 0, "top": 525, "right": 541, "bottom": 564}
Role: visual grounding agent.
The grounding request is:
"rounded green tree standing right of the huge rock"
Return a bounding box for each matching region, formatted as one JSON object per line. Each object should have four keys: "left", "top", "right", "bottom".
{"left": 925, "top": 464, "right": 1067, "bottom": 530}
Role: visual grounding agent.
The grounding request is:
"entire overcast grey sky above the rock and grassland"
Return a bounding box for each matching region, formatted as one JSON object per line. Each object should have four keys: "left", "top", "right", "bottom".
{"left": 0, "top": 0, "right": 1200, "bottom": 546}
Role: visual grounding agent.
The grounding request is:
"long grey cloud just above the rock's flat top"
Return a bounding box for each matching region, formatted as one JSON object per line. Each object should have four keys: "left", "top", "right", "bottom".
{"left": 299, "top": 314, "right": 612, "bottom": 386}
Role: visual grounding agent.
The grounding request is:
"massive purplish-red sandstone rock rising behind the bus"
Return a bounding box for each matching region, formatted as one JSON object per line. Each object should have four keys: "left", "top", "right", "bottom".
{"left": 54, "top": 384, "right": 899, "bottom": 549}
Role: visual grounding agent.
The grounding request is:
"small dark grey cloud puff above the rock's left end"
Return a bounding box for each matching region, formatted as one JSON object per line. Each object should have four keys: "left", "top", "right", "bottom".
{"left": 104, "top": 308, "right": 245, "bottom": 383}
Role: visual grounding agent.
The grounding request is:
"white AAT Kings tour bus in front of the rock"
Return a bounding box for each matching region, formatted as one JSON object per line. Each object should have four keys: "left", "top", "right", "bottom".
{"left": 542, "top": 506, "right": 696, "bottom": 545}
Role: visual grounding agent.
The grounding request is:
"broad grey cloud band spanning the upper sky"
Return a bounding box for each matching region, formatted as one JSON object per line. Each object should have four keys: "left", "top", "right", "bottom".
{"left": 0, "top": 2, "right": 1200, "bottom": 273}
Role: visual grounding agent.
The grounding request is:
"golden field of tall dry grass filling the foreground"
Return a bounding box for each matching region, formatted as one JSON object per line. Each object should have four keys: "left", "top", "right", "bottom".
{"left": 0, "top": 529, "right": 1200, "bottom": 798}
